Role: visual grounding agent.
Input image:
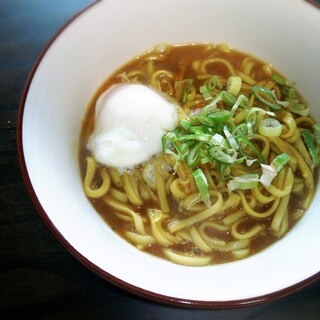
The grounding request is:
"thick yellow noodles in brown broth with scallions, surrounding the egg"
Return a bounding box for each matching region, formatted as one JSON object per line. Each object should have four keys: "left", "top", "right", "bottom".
{"left": 79, "top": 44, "right": 320, "bottom": 266}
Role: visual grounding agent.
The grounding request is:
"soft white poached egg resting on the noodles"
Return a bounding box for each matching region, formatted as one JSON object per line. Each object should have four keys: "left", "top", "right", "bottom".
{"left": 88, "top": 83, "right": 178, "bottom": 169}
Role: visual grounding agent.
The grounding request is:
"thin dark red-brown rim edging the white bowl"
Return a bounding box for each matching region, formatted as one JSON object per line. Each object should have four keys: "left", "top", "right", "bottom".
{"left": 17, "top": 0, "right": 320, "bottom": 309}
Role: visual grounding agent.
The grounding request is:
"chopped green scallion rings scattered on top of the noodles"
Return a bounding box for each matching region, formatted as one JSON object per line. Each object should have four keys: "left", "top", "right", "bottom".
{"left": 162, "top": 75, "right": 308, "bottom": 194}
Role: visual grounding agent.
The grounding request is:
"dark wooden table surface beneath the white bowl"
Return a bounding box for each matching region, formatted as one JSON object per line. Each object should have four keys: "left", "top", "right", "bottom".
{"left": 0, "top": 0, "right": 320, "bottom": 320}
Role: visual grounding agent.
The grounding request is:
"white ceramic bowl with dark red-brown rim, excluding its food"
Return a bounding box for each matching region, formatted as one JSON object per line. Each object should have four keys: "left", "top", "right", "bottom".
{"left": 18, "top": 0, "right": 320, "bottom": 307}
